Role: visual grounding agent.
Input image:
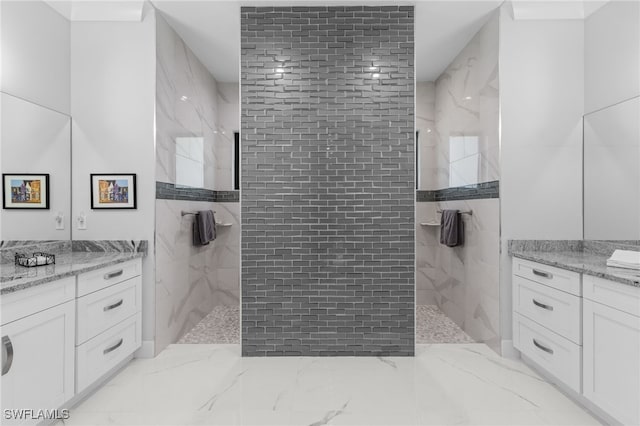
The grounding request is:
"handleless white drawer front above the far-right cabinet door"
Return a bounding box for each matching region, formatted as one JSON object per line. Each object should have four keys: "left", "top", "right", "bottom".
{"left": 582, "top": 275, "right": 640, "bottom": 317}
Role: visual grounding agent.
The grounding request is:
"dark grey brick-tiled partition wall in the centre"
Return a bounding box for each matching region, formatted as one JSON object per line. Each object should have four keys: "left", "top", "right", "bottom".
{"left": 241, "top": 6, "right": 415, "bottom": 356}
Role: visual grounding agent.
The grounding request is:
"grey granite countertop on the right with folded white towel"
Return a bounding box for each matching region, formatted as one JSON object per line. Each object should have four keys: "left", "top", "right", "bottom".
{"left": 509, "top": 241, "right": 640, "bottom": 287}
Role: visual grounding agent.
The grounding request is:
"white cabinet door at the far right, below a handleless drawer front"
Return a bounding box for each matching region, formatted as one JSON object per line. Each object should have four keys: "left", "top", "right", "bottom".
{"left": 583, "top": 299, "right": 640, "bottom": 425}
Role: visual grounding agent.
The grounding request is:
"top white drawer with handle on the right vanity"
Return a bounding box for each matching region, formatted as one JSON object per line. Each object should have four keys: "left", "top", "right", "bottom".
{"left": 512, "top": 257, "right": 582, "bottom": 296}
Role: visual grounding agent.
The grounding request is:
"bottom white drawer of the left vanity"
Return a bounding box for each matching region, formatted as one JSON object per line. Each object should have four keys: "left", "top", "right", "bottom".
{"left": 76, "top": 313, "right": 141, "bottom": 393}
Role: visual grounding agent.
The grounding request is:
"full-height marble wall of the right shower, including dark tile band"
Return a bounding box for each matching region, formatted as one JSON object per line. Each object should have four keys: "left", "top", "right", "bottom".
{"left": 416, "top": 15, "right": 500, "bottom": 350}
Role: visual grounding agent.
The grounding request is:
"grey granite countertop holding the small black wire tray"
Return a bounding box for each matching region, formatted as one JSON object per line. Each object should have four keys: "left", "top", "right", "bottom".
{"left": 0, "top": 241, "right": 146, "bottom": 295}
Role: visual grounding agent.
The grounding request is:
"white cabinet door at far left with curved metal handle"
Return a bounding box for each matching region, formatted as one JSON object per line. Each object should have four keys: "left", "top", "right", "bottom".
{"left": 0, "top": 300, "right": 75, "bottom": 424}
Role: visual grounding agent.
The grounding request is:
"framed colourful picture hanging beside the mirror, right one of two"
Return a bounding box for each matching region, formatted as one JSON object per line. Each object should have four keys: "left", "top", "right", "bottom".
{"left": 91, "top": 173, "right": 136, "bottom": 209}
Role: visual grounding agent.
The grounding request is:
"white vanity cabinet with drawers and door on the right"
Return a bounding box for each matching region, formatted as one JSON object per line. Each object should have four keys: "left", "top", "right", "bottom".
{"left": 512, "top": 257, "right": 640, "bottom": 425}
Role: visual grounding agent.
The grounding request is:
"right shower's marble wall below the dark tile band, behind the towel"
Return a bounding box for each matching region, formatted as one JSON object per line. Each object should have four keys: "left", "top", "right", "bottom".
{"left": 416, "top": 199, "right": 500, "bottom": 351}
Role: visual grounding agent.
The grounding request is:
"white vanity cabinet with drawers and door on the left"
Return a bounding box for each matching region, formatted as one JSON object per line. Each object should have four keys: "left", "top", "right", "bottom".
{"left": 1, "top": 259, "right": 142, "bottom": 424}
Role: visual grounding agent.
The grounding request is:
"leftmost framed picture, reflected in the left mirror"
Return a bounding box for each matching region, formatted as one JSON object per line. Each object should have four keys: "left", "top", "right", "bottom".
{"left": 2, "top": 173, "right": 49, "bottom": 210}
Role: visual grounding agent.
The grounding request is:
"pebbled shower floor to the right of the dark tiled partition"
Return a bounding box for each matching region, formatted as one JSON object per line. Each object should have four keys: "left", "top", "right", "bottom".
{"left": 416, "top": 305, "right": 474, "bottom": 343}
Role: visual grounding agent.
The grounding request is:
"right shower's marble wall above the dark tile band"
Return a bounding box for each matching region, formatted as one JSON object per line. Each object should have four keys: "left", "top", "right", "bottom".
{"left": 430, "top": 15, "right": 499, "bottom": 189}
